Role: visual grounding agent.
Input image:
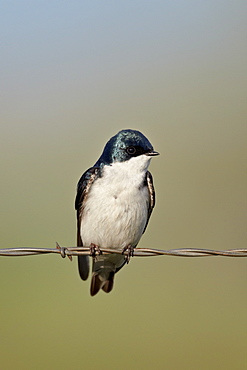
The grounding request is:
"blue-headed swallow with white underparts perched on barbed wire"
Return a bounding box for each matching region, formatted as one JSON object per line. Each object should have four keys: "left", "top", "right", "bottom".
{"left": 75, "top": 129, "right": 159, "bottom": 296}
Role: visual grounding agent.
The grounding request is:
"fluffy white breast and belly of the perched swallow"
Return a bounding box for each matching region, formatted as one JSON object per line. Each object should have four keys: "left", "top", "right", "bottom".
{"left": 81, "top": 155, "right": 150, "bottom": 249}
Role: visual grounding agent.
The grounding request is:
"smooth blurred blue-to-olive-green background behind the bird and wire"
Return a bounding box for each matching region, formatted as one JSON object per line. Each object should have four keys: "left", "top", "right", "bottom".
{"left": 0, "top": 0, "right": 247, "bottom": 370}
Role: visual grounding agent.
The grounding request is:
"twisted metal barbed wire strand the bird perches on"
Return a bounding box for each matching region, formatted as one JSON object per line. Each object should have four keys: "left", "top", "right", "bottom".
{"left": 0, "top": 243, "right": 247, "bottom": 260}
